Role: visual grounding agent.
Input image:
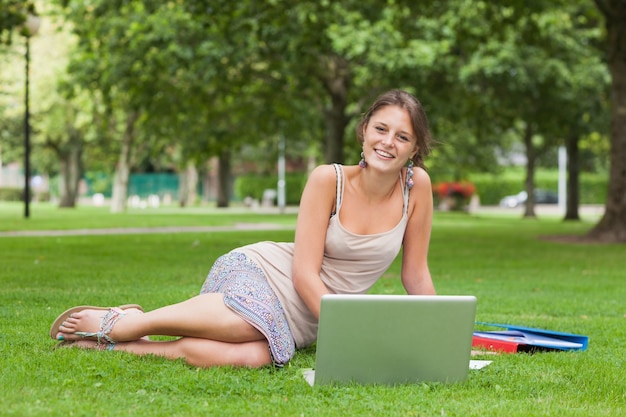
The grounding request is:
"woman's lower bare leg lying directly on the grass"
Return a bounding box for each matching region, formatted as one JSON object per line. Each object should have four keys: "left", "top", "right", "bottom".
{"left": 70, "top": 337, "right": 272, "bottom": 368}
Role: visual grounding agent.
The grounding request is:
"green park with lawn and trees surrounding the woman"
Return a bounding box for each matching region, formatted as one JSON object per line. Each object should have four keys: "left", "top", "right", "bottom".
{"left": 0, "top": 0, "right": 626, "bottom": 416}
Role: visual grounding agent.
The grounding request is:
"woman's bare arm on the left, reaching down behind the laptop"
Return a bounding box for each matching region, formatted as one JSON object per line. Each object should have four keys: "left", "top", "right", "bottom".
{"left": 293, "top": 165, "right": 337, "bottom": 319}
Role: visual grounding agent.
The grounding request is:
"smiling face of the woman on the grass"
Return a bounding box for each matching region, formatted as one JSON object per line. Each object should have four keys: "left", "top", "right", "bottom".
{"left": 363, "top": 105, "right": 417, "bottom": 169}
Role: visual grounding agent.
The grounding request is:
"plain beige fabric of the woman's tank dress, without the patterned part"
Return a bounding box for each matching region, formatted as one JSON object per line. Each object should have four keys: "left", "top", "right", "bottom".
{"left": 236, "top": 164, "right": 409, "bottom": 348}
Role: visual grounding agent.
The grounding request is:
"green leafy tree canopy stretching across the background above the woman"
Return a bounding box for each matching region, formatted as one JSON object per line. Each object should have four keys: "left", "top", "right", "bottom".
{"left": 0, "top": 0, "right": 610, "bottom": 218}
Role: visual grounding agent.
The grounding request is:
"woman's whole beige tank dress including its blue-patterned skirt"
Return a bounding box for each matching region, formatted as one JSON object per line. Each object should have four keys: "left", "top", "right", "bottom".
{"left": 200, "top": 164, "right": 409, "bottom": 367}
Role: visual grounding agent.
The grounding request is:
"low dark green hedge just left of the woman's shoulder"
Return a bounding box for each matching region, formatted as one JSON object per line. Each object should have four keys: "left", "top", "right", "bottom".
{"left": 234, "top": 173, "right": 307, "bottom": 205}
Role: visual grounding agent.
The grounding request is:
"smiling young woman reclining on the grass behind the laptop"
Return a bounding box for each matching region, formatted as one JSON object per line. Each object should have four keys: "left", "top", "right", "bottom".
{"left": 50, "top": 90, "right": 435, "bottom": 367}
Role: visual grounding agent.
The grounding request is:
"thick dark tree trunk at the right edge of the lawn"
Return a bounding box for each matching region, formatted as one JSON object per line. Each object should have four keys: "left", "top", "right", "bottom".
{"left": 589, "top": 0, "right": 626, "bottom": 243}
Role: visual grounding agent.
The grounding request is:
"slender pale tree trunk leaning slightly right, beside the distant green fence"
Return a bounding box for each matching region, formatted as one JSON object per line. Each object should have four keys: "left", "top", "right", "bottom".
{"left": 111, "top": 111, "right": 139, "bottom": 213}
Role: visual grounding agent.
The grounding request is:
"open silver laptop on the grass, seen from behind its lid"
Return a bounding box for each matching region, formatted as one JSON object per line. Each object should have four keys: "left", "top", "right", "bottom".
{"left": 305, "top": 295, "right": 476, "bottom": 385}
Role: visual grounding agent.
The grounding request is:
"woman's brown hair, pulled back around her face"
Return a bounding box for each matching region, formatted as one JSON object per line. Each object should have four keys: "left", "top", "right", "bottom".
{"left": 356, "top": 90, "right": 432, "bottom": 168}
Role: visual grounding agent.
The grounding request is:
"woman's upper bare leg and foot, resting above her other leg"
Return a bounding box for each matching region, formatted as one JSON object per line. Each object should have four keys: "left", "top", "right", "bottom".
{"left": 59, "top": 293, "right": 265, "bottom": 343}
